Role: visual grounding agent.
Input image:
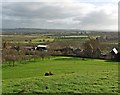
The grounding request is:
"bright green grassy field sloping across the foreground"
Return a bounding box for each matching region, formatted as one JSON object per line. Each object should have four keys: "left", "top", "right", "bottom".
{"left": 2, "top": 57, "right": 118, "bottom": 94}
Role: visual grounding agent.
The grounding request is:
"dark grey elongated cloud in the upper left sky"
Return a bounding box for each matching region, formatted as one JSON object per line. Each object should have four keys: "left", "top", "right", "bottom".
{"left": 3, "top": 2, "right": 77, "bottom": 19}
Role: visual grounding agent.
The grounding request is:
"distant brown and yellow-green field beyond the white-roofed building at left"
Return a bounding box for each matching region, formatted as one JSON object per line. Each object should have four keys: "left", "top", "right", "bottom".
{"left": 3, "top": 35, "right": 54, "bottom": 43}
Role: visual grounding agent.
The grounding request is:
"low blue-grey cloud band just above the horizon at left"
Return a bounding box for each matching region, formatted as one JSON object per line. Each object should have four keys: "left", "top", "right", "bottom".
{"left": 2, "top": 19, "right": 76, "bottom": 28}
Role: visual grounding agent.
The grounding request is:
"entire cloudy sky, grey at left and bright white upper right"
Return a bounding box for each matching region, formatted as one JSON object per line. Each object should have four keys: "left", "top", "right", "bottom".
{"left": 0, "top": 0, "right": 119, "bottom": 30}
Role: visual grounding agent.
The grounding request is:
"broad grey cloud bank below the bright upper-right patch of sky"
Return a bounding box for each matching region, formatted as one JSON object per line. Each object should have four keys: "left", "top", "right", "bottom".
{"left": 2, "top": 2, "right": 117, "bottom": 29}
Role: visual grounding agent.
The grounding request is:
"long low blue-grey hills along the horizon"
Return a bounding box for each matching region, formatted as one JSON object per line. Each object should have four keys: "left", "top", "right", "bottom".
{"left": 2, "top": 28, "right": 117, "bottom": 35}
